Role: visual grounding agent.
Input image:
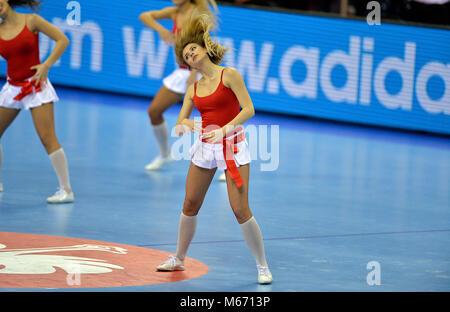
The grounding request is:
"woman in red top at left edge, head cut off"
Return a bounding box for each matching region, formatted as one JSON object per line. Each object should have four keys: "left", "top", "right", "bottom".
{"left": 0, "top": 0, "right": 74, "bottom": 203}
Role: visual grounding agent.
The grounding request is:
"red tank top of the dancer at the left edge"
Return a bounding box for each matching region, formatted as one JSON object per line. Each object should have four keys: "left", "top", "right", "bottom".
{"left": 0, "top": 15, "right": 41, "bottom": 82}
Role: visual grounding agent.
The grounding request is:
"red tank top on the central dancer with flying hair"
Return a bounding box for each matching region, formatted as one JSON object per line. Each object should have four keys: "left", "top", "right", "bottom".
{"left": 193, "top": 69, "right": 240, "bottom": 137}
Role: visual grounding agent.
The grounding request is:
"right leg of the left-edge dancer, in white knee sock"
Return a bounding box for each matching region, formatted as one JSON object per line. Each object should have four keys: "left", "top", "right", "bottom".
{"left": 31, "top": 103, "right": 74, "bottom": 204}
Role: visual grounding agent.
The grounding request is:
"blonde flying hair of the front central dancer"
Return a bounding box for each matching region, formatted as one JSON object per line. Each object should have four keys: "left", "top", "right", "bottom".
{"left": 175, "top": 14, "right": 229, "bottom": 69}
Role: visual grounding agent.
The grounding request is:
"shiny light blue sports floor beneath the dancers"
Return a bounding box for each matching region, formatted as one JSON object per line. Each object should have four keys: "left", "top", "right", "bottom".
{"left": 0, "top": 87, "right": 450, "bottom": 292}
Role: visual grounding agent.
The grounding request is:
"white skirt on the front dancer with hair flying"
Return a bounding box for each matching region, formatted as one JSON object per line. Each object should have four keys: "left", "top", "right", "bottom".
{"left": 189, "top": 139, "right": 251, "bottom": 170}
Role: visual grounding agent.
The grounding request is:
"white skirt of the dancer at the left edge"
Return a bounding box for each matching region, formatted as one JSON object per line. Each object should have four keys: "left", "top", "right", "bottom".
{"left": 0, "top": 78, "right": 59, "bottom": 110}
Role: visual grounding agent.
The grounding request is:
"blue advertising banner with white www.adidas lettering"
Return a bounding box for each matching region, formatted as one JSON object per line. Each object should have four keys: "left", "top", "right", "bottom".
{"left": 0, "top": 0, "right": 450, "bottom": 134}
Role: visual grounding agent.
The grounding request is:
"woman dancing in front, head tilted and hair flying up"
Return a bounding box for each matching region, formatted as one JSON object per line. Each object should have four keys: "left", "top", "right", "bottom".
{"left": 157, "top": 15, "right": 272, "bottom": 284}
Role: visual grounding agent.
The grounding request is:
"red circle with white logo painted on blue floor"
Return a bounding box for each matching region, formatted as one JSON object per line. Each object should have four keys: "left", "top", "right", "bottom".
{"left": 0, "top": 232, "right": 209, "bottom": 288}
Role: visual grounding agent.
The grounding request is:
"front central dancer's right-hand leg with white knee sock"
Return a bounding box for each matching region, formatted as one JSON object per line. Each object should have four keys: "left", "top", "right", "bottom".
{"left": 225, "top": 165, "right": 273, "bottom": 284}
